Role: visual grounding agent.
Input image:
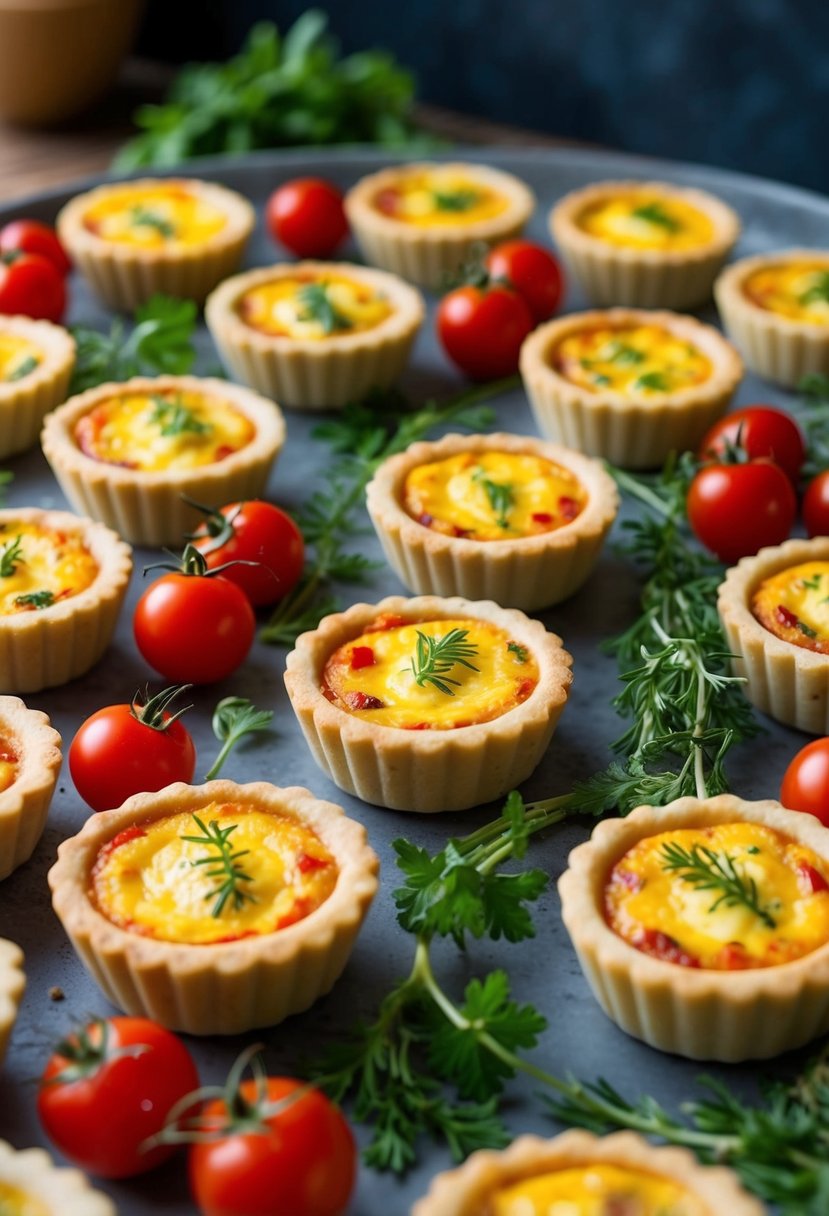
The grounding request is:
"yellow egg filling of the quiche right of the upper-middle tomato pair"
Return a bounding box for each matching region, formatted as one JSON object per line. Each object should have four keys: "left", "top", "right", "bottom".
{"left": 549, "top": 325, "right": 712, "bottom": 401}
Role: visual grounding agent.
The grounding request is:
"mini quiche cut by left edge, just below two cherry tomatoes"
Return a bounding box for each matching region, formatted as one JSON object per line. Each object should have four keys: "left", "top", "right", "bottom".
{"left": 0, "top": 316, "right": 75, "bottom": 460}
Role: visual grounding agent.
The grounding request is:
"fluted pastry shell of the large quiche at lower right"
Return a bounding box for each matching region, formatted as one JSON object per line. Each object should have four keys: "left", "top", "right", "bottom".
{"left": 558, "top": 794, "right": 829, "bottom": 1063}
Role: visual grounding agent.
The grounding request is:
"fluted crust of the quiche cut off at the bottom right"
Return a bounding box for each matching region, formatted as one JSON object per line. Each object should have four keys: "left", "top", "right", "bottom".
{"left": 412, "top": 1131, "right": 765, "bottom": 1216}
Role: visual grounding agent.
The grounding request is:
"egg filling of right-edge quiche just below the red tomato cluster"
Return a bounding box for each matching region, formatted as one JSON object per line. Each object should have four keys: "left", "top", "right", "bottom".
{"left": 751, "top": 562, "right": 829, "bottom": 654}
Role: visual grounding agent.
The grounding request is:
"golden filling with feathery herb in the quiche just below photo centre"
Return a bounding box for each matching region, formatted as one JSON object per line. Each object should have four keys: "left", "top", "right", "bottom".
{"left": 322, "top": 615, "right": 538, "bottom": 731}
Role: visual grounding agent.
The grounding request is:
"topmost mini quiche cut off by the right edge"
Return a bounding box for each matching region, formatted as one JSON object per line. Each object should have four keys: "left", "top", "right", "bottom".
{"left": 714, "top": 249, "right": 829, "bottom": 388}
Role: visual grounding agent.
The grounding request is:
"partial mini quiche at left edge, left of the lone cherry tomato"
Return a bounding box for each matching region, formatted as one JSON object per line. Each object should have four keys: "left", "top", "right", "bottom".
{"left": 0, "top": 697, "right": 62, "bottom": 879}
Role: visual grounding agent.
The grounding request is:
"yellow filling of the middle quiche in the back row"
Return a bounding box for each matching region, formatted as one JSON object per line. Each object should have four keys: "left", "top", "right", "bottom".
{"left": 373, "top": 168, "right": 508, "bottom": 227}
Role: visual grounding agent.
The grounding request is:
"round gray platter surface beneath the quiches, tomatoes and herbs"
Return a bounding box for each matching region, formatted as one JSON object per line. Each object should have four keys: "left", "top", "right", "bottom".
{"left": 0, "top": 148, "right": 829, "bottom": 1216}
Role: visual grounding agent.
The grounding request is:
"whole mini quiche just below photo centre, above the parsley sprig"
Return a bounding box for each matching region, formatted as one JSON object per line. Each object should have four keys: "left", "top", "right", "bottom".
{"left": 284, "top": 596, "right": 573, "bottom": 811}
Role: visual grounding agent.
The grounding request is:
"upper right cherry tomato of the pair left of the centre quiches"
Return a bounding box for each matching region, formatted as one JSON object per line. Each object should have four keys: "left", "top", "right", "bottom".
{"left": 192, "top": 501, "right": 305, "bottom": 607}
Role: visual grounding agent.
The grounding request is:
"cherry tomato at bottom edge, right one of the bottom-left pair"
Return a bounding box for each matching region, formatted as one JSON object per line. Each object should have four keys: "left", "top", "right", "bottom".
{"left": 188, "top": 1076, "right": 356, "bottom": 1216}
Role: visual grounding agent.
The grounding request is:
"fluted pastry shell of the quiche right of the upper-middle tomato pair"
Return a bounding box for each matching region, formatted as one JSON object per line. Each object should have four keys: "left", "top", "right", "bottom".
{"left": 520, "top": 309, "right": 743, "bottom": 468}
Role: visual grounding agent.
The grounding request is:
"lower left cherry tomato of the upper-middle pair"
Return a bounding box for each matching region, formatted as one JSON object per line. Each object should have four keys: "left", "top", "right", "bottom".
{"left": 438, "top": 286, "right": 532, "bottom": 381}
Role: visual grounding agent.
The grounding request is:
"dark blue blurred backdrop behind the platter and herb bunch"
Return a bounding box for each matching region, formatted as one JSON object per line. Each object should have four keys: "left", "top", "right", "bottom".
{"left": 139, "top": 0, "right": 829, "bottom": 192}
